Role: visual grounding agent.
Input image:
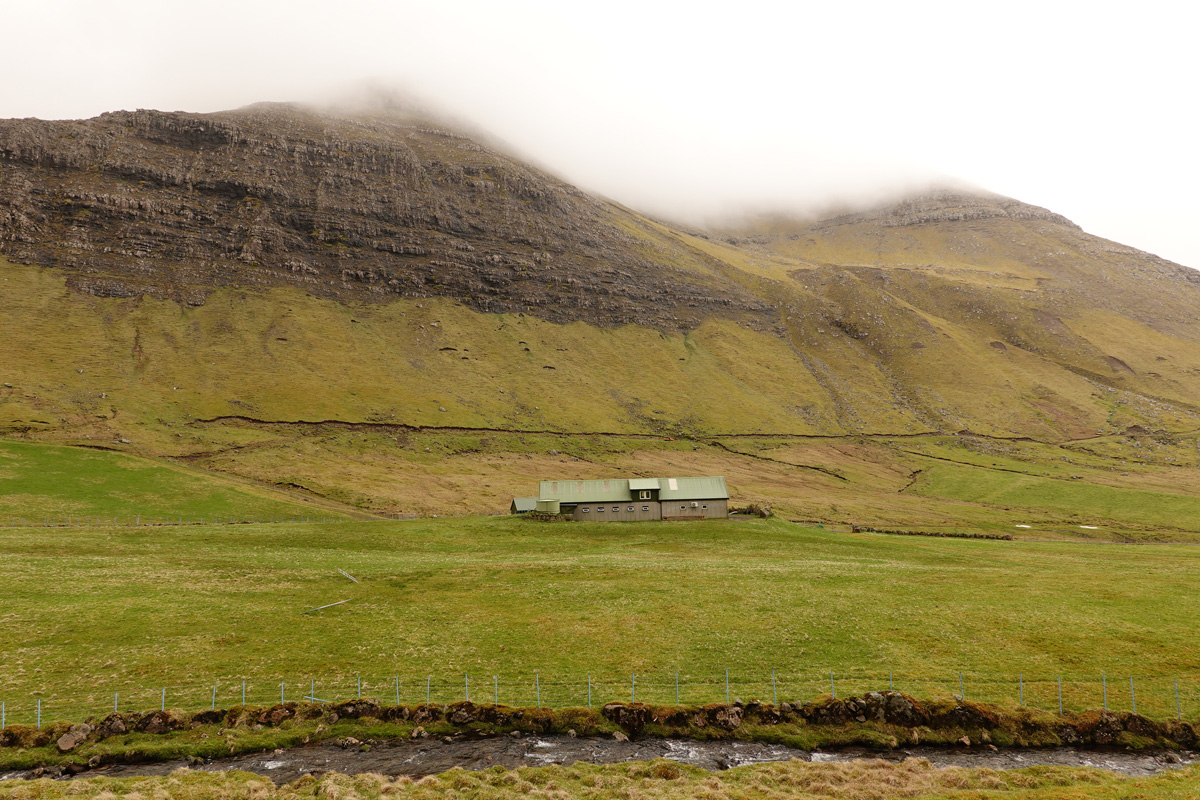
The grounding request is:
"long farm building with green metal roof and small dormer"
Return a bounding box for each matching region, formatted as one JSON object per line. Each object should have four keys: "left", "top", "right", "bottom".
{"left": 514, "top": 477, "right": 730, "bottom": 522}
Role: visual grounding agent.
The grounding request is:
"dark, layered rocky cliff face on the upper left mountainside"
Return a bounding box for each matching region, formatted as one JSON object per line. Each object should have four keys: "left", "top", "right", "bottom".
{"left": 0, "top": 104, "right": 770, "bottom": 327}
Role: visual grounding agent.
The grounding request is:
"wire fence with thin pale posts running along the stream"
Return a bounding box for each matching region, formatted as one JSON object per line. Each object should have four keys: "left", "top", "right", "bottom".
{"left": 0, "top": 670, "right": 1200, "bottom": 727}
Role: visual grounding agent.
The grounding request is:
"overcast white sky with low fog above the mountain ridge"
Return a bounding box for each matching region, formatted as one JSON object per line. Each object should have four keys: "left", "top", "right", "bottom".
{"left": 9, "top": 0, "right": 1200, "bottom": 267}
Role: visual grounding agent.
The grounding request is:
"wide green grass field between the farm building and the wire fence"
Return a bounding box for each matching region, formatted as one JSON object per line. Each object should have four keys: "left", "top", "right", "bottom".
{"left": 0, "top": 517, "right": 1200, "bottom": 720}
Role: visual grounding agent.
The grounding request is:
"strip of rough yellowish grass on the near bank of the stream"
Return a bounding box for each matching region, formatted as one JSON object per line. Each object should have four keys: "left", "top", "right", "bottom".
{"left": 9, "top": 759, "right": 1200, "bottom": 800}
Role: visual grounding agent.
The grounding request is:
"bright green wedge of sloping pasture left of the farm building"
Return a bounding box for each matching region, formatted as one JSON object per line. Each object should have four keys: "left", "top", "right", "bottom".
{"left": 0, "top": 440, "right": 340, "bottom": 525}
